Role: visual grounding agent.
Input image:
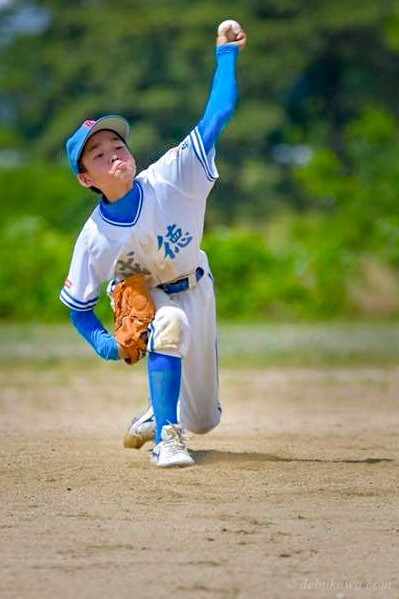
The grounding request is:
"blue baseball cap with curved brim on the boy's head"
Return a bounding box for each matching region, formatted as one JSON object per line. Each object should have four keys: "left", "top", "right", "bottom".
{"left": 65, "top": 114, "right": 129, "bottom": 175}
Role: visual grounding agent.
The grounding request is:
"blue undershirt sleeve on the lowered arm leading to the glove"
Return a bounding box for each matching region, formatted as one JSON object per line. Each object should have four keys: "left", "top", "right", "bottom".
{"left": 70, "top": 310, "right": 119, "bottom": 360}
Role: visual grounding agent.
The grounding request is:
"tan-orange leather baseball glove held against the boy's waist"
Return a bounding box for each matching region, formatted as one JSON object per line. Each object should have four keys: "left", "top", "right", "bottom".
{"left": 112, "top": 274, "right": 155, "bottom": 364}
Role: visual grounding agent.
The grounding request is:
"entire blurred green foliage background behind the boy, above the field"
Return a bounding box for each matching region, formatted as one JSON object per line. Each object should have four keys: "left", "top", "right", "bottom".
{"left": 0, "top": 0, "right": 399, "bottom": 320}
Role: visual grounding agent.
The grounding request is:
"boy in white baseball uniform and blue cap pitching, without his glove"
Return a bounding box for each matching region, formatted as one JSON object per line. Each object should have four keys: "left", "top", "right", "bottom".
{"left": 60, "top": 21, "right": 246, "bottom": 467}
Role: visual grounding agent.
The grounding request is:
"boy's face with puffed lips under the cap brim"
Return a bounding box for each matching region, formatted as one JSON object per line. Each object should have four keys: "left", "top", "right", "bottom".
{"left": 78, "top": 129, "right": 136, "bottom": 197}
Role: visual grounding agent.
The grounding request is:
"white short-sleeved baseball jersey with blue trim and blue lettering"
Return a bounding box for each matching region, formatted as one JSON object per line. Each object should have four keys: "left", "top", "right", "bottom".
{"left": 60, "top": 128, "right": 218, "bottom": 311}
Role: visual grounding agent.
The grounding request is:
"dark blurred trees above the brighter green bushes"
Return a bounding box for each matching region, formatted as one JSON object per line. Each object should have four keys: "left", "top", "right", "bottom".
{"left": 0, "top": 0, "right": 399, "bottom": 224}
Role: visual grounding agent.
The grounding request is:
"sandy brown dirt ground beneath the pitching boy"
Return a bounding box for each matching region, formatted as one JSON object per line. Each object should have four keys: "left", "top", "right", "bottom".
{"left": 0, "top": 360, "right": 399, "bottom": 599}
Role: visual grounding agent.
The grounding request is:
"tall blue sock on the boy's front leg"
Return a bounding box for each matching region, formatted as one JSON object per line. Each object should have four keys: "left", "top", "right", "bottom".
{"left": 148, "top": 352, "right": 181, "bottom": 443}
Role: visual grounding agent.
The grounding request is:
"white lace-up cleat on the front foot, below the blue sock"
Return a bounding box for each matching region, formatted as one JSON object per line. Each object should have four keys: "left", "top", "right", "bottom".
{"left": 150, "top": 424, "right": 195, "bottom": 468}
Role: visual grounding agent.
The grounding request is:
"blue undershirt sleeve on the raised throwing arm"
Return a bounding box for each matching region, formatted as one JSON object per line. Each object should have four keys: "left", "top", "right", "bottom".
{"left": 198, "top": 44, "right": 238, "bottom": 153}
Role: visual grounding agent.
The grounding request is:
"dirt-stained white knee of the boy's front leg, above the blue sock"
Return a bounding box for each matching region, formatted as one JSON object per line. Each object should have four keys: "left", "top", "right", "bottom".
{"left": 148, "top": 306, "right": 190, "bottom": 357}
